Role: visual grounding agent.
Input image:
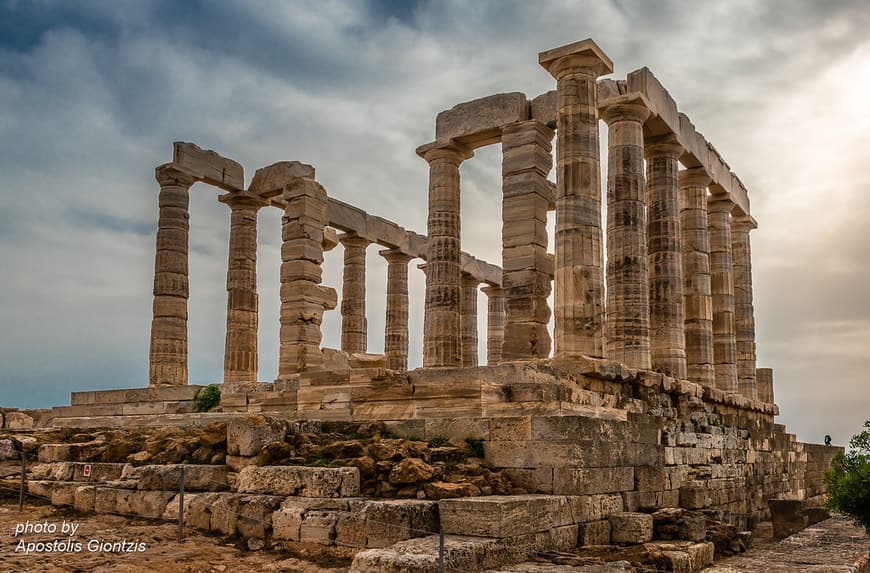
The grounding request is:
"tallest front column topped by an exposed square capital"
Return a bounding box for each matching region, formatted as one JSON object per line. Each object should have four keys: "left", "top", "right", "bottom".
{"left": 538, "top": 40, "right": 613, "bottom": 358}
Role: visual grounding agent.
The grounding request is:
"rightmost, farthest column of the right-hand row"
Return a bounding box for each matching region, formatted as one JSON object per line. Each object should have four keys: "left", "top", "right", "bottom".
{"left": 731, "top": 215, "right": 758, "bottom": 398}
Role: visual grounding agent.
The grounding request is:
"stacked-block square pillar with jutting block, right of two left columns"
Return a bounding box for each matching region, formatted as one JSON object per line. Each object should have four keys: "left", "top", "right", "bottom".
{"left": 278, "top": 177, "right": 337, "bottom": 380}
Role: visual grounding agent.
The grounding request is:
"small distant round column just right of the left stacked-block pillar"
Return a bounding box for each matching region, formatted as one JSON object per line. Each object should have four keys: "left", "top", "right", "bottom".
{"left": 338, "top": 233, "right": 370, "bottom": 354}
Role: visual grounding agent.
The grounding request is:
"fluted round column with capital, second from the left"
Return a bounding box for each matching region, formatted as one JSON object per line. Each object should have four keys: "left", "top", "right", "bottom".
{"left": 219, "top": 193, "right": 266, "bottom": 382}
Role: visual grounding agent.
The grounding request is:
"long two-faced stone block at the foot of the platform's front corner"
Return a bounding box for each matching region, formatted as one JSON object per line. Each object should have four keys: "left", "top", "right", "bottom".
{"left": 438, "top": 495, "right": 574, "bottom": 538}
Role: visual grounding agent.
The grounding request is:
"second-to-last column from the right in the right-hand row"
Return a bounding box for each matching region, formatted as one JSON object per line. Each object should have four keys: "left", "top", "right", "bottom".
{"left": 707, "top": 195, "right": 738, "bottom": 392}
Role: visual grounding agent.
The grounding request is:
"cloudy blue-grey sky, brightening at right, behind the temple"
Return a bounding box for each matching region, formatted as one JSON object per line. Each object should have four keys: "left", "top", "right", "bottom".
{"left": 0, "top": 0, "right": 870, "bottom": 443}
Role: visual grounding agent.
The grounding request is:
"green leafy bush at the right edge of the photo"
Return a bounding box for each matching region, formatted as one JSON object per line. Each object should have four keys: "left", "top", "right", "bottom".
{"left": 825, "top": 420, "right": 870, "bottom": 533}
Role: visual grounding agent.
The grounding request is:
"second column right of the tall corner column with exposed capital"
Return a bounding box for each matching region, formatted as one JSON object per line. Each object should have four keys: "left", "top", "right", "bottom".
{"left": 644, "top": 136, "right": 686, "bottom": 380}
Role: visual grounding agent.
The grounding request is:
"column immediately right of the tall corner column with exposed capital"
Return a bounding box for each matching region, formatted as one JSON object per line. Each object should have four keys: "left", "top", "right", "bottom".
{"left": 602, "top": 96, "right": 650, "bottom": 369}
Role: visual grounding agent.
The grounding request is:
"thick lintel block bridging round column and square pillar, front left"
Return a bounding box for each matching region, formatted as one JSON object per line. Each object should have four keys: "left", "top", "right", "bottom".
{"left": 435, "top": 92, "right": 529, "bottom": 145}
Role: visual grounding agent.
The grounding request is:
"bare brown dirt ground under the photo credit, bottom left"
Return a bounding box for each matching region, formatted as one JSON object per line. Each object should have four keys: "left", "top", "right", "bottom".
{"left": 0, "top": 500, "right": 348, "bottom": 573}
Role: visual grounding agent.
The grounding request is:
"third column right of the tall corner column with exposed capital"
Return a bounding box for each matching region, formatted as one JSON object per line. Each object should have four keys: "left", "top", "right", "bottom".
{"left": 680, "top": 167, "right": 716, "bottom": 388}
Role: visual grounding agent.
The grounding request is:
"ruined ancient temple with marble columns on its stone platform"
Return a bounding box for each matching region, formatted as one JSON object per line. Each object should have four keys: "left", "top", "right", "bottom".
{"left": 34, "top": 40, "right": 852, "bottom": 571}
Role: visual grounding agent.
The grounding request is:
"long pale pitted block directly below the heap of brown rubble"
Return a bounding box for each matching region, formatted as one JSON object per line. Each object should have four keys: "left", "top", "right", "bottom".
{"left": 238, "top": 466, "right": 360, "bottom": 497}
